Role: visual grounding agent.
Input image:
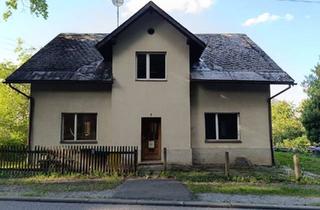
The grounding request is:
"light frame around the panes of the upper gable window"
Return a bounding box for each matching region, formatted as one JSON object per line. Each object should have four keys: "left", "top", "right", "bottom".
{"left": 135, "top": 51, "right": 167, "bottom": 82}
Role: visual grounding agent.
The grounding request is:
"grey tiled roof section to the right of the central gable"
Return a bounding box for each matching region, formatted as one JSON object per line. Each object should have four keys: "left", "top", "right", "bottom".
{"left": 191, "top": 34, "right": 294, "bottom": 84}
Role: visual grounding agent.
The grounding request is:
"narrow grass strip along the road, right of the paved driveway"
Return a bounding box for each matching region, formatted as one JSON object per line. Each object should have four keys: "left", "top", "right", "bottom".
{"left": 186, "top": 182, "right": 320, "bottom": 197}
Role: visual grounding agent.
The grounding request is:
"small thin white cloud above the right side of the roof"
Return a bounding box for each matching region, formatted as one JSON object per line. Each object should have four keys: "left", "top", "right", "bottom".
{"left": 242, "top": 12, "right": 294, "bottom": 26}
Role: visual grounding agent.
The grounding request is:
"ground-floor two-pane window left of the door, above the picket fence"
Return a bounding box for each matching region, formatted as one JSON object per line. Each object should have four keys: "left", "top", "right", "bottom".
{"left": 62, "top": 113, "right": 97, "bottom": 141}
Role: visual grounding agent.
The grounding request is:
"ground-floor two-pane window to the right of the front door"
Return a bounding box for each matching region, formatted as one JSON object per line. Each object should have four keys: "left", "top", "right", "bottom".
{"left": 204, "top": 113, "right": 240, "bottom": 140}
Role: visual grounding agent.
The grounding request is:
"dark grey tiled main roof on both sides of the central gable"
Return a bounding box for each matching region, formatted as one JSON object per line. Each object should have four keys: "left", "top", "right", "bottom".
{"left": 6, "top": 34, "right": 294, "bottom": 84}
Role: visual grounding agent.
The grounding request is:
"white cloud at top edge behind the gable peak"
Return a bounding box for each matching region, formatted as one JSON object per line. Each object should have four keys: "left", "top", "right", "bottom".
{"left": 123, "top": 0, "right": 215, "bottom": 17}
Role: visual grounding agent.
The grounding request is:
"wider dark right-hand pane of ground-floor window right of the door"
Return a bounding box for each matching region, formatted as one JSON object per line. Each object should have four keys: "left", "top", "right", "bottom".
{"left": 218, "top": 114, "right": 238, "bottom": 139}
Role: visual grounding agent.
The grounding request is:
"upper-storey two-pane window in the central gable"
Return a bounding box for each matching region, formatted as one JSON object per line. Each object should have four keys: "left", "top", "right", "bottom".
{"left": 137, "top": 53, "right": 166, "bottom": 80}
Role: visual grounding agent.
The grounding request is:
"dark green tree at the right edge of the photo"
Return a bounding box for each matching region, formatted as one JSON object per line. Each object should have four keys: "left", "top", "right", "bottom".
{"left": 301, "top": 63, "right": 320, "bottom": 143}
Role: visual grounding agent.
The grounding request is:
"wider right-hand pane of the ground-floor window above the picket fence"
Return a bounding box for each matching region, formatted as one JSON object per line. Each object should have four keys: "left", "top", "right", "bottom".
{"left": 77, "top": 114, "right": 97, "bottom": 140}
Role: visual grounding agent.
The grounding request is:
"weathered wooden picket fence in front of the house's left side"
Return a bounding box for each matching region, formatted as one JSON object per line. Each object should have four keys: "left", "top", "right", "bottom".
{"left": 0, "top": 146, "right": 138, "bottom": 174}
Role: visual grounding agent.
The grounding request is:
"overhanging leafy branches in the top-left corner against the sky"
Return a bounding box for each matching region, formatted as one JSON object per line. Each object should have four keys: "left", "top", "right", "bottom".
{"left": 2, "top": 0, "right": 48, "bottom": 21}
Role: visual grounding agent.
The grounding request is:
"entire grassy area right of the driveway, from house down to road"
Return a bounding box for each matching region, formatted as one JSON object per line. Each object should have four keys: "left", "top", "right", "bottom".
{"left": 163, "top": 152, "right": 320, "bottom": 197}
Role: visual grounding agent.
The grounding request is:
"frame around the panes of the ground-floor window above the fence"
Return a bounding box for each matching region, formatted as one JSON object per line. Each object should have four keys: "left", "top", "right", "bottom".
{"left": 60, "top": 112, "right": 98, "bottom": 144}
